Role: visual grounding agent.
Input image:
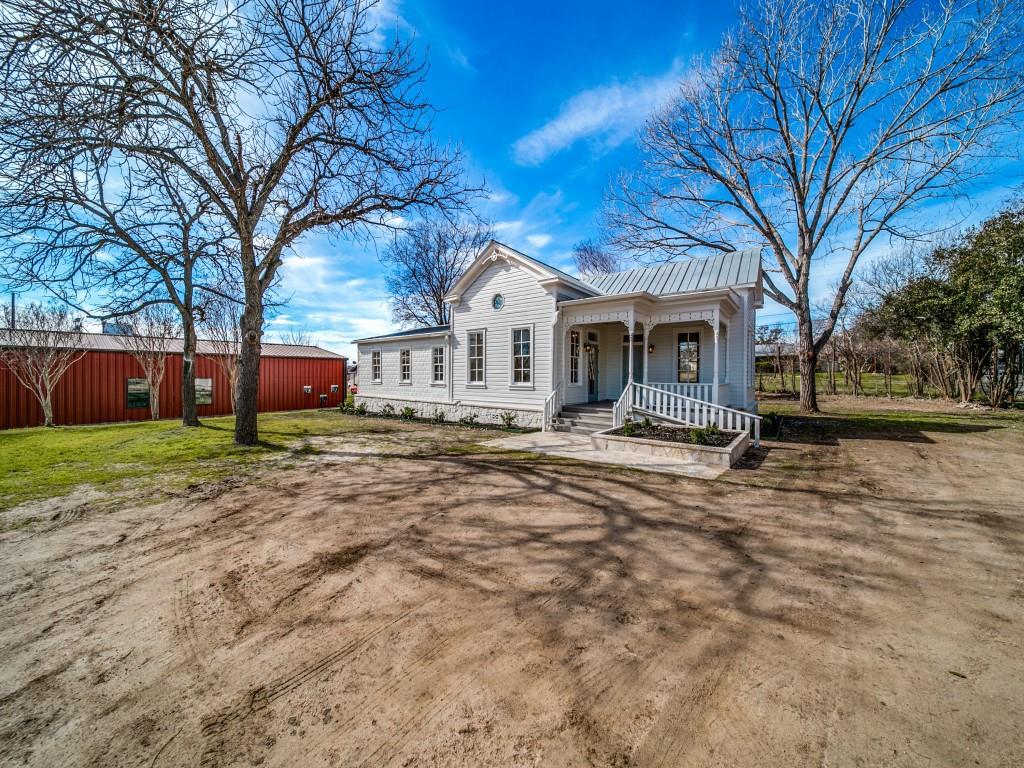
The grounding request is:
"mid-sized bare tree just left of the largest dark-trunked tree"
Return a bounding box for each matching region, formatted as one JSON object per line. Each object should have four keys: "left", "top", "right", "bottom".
{"left": 0, "top": 150, "right": 239, "bottom": 426}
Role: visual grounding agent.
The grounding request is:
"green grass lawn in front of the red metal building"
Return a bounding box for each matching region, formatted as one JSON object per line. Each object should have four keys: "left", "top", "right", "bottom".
{"left": 0, "top": 411, "right": 413, "bottom": 510}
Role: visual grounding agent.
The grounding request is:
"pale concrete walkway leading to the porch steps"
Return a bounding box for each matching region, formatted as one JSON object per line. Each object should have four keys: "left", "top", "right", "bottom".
{"left": 484, "top": 432, "right": 725, "bottom": 480}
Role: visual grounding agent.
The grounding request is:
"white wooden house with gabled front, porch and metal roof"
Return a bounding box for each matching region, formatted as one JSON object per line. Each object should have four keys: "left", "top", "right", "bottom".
{"left": 354, "top": 241, "right": 763, "bottom": 438}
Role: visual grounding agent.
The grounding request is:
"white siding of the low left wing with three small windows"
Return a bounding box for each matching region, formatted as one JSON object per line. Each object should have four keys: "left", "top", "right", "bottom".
{"left": 358, "top": 336, "right": 452, "bottom": 402}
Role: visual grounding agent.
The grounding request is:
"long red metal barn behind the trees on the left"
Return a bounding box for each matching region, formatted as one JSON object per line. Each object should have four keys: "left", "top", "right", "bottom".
{"left": 0, "top": 334, "right": 347, "bottom": 429}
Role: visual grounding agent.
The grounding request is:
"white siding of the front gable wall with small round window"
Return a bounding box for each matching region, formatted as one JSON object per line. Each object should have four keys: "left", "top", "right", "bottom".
{"left": 452, "top": 261, "right": 555, "bottom": 409}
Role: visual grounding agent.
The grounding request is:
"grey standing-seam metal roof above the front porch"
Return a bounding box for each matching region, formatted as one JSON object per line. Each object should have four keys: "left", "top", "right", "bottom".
{"left": 590, "top": 248, "right": 761, "bottom": 296}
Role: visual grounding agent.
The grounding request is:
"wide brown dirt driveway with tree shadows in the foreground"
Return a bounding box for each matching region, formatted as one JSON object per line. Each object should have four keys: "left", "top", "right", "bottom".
{"left": 0, "top": 405, "right": 1024, "bottom": 768}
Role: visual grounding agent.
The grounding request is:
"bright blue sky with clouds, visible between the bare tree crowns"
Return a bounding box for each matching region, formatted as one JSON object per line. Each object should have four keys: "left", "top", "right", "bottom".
{"left": 4, "top": 0, "right": 1021, "bottom": 355}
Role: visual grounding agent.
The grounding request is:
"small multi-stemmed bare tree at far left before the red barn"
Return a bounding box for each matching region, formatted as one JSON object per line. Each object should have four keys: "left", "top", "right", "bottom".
{"left": 0, "top": 304, "right": 85, "bottom": 427}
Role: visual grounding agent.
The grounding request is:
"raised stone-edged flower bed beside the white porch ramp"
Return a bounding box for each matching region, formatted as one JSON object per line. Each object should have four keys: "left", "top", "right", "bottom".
{"left": 590, "top": 422, "right": 751, "bottom": 468}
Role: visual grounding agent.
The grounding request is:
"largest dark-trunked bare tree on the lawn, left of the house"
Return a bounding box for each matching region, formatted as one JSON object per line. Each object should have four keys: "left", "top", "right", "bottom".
{"left": 0, "top": 0, "right": 466, "bottom": 444}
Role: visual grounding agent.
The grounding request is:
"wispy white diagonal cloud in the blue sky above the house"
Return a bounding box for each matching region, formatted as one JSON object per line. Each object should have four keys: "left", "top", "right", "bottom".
{"left": 512, "top": 65, "right": 683, "bottom": 165}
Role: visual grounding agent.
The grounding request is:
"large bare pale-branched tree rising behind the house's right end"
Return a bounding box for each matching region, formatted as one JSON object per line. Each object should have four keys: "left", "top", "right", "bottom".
{"left": 608, "top": 0, "right": 1024, "bottom": 412}
